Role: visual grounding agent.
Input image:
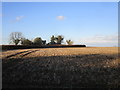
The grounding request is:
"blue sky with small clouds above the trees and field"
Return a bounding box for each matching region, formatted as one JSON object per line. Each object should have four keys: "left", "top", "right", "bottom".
{"left": 2, "top": 2, "right": 118, "bottom": 46}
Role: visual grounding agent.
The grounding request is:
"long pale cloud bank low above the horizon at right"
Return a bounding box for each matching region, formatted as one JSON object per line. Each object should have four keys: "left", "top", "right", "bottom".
{"left": 76, "top": 34, "right": 118, "bottom": 46}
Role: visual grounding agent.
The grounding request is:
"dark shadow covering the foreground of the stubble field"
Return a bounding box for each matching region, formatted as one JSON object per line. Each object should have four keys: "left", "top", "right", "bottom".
{"left": 2, "top": 54, "right": 120, "bottom": 88}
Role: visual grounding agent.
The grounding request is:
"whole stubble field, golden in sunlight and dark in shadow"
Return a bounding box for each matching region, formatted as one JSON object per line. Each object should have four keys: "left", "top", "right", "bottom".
{"left": 0, "top": 47, "right": 120, "bottom": 88}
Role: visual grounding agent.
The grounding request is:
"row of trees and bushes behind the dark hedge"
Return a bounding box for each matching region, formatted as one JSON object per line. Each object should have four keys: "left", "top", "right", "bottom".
{"left": 10, "top": 32, "right": 73, "bottom": 45}
